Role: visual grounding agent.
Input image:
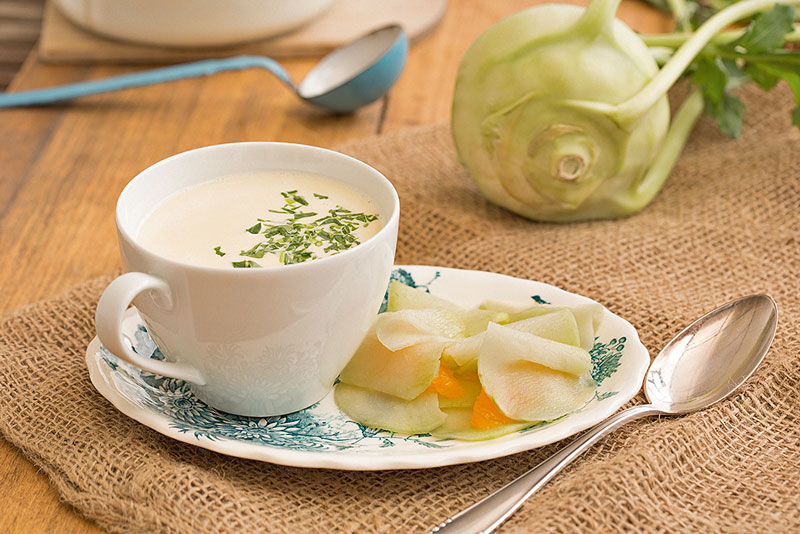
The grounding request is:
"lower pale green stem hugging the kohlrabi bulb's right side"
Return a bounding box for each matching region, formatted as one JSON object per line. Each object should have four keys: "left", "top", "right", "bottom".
{"left": 633, "top": 89, "right": 705, "bottom": 209}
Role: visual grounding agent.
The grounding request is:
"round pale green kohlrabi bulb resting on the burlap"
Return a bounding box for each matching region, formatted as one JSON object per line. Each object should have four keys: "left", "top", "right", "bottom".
{"left": 452, "top": 0, "right": 670, "bottom": 222}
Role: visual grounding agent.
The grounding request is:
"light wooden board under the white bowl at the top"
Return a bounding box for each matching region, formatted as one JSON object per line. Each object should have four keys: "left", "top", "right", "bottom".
{"left": 39, "top": 0, "right": 447, "bottom": 64}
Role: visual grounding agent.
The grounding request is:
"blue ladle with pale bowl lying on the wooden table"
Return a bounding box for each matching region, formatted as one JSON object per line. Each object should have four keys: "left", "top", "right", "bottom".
{"left": 0, "top": 25, "right": 408, "bottom": 113}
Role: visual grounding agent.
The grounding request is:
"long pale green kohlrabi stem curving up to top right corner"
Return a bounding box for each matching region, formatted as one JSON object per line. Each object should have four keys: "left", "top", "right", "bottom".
{"left": 612, "top": 0, "right": 800, "bottom": 124}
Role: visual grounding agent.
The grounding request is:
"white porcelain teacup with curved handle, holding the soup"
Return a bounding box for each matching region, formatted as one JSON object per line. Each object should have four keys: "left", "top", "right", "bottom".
{"left": 95, "top": 143, "right": 399, "bottom": 416}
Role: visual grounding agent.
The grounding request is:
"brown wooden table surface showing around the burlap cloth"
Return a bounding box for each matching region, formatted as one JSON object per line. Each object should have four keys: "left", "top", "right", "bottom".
{"left": 0, "top": 0, "right": 670, "bottom": 534}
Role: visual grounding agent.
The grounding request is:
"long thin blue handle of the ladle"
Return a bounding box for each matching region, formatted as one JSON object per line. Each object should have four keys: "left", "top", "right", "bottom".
{"left": 0, "top": 56, "right": 294, "bottom": 108}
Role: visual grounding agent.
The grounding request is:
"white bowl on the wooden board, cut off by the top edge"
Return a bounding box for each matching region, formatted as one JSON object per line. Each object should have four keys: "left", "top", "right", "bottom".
{"left": 56, "top": 0, "right": 333, "bottom": 47}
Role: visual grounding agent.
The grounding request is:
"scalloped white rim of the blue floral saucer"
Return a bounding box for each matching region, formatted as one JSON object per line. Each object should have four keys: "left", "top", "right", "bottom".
{"left": 86, "top": 265, "right": 650, "bottom": 471}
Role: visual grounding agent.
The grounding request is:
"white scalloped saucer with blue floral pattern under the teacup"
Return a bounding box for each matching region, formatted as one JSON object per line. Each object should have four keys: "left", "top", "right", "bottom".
{"left": 86, "top": 266, "right": 650, "bottom": 470}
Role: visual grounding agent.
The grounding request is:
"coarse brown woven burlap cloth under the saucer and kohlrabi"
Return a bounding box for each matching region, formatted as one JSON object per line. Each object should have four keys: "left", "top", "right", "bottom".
{"left": 0, "top": 85, "right": 800, "bottom": 533}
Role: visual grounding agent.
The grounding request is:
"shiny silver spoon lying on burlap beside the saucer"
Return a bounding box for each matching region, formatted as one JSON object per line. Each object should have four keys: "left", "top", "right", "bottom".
{"left": 428, "top": 295, "right": 778, "bottom": 534}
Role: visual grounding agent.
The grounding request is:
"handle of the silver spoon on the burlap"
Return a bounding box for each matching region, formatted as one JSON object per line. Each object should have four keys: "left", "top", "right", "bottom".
{"left": 427, "top": 404, "right": 663, "bottom": 534}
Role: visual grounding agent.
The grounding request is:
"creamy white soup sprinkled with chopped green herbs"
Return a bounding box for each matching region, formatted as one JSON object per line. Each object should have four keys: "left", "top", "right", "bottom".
{"left": 137, "top": 171, "right": 383, "bottom": 268}
